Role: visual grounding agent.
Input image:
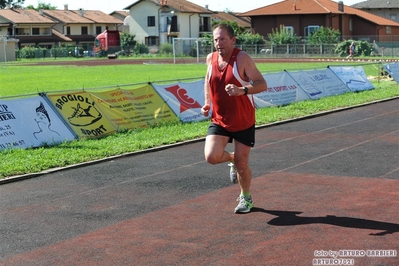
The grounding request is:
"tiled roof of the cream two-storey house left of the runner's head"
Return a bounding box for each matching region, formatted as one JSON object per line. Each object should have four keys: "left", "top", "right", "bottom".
{"left": 124, "top": 0, "right": 214, "bottom": 14}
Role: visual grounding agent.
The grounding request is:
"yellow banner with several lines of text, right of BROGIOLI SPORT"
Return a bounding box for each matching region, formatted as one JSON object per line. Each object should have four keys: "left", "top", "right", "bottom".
{"left": 90, "top": 85, "right": 176, "bottom": 130}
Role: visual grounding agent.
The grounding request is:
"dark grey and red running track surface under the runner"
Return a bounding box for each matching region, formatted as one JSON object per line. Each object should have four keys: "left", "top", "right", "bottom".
{"left": 0, "top": 99, "right": 399, "bottom": 266}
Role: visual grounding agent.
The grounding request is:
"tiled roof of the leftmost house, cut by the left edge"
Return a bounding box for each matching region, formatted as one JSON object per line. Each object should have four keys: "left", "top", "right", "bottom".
{"left": 0, "top": 9, "right": 56, "bottom": 24}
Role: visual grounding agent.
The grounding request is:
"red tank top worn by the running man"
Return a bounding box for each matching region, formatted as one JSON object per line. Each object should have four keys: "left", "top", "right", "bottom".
{"left": 208, "top": 48, "right": 255, "bottom": 132}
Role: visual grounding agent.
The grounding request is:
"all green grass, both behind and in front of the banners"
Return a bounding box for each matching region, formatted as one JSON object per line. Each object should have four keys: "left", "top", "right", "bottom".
{"left": 0, "top": 59, "right": 399, "bottom": 179}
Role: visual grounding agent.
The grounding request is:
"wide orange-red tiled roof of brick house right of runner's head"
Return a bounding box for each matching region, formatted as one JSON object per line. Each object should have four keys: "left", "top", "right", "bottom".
{"left": 240, "top": 0, "right": 399, "bottom": 26}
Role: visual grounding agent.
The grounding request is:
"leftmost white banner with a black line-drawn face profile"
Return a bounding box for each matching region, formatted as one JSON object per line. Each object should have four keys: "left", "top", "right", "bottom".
{"left": 0, "top": 96, "right": 75, "bottom": 150}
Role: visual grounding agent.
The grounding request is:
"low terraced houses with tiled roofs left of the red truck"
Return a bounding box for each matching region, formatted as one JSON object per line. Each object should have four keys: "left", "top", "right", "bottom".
{"left": 0, "top": 5, "right": 123, "bottom": 50}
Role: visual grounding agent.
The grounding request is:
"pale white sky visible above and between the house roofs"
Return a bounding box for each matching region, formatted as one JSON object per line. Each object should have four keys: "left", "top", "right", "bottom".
{"left": 23, "top": 0, "right": 363, "bottom": 14}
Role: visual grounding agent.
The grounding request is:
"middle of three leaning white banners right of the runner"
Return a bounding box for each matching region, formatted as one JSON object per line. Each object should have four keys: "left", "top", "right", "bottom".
{"left": 288, "top": 69, "right": 350, "bottom": 99}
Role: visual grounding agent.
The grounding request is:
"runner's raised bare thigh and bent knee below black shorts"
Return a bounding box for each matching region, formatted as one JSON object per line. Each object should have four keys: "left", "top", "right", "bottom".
{"left": 204, "top": 135, "right": 234, "bottom": 164}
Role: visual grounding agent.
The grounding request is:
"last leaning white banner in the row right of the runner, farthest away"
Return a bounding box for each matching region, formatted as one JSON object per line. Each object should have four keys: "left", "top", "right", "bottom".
{"left": 329, "top": 66, "right": 375, "bottom": 91}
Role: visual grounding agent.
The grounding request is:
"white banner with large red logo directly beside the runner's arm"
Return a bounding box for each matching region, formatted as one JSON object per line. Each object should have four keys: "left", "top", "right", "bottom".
{"left": 152, "top": 80, "right": 211, "bottom": 122}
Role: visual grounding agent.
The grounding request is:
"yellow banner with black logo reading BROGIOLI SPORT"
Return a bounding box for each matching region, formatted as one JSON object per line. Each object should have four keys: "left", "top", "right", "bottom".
{"left": 47, "top": 92, "right": 116, "bottom": 138}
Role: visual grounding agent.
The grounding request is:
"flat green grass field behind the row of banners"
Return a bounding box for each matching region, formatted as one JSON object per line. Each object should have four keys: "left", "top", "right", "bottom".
{"left": 0, "top": 58, "right": 380, "bottom": 98}
